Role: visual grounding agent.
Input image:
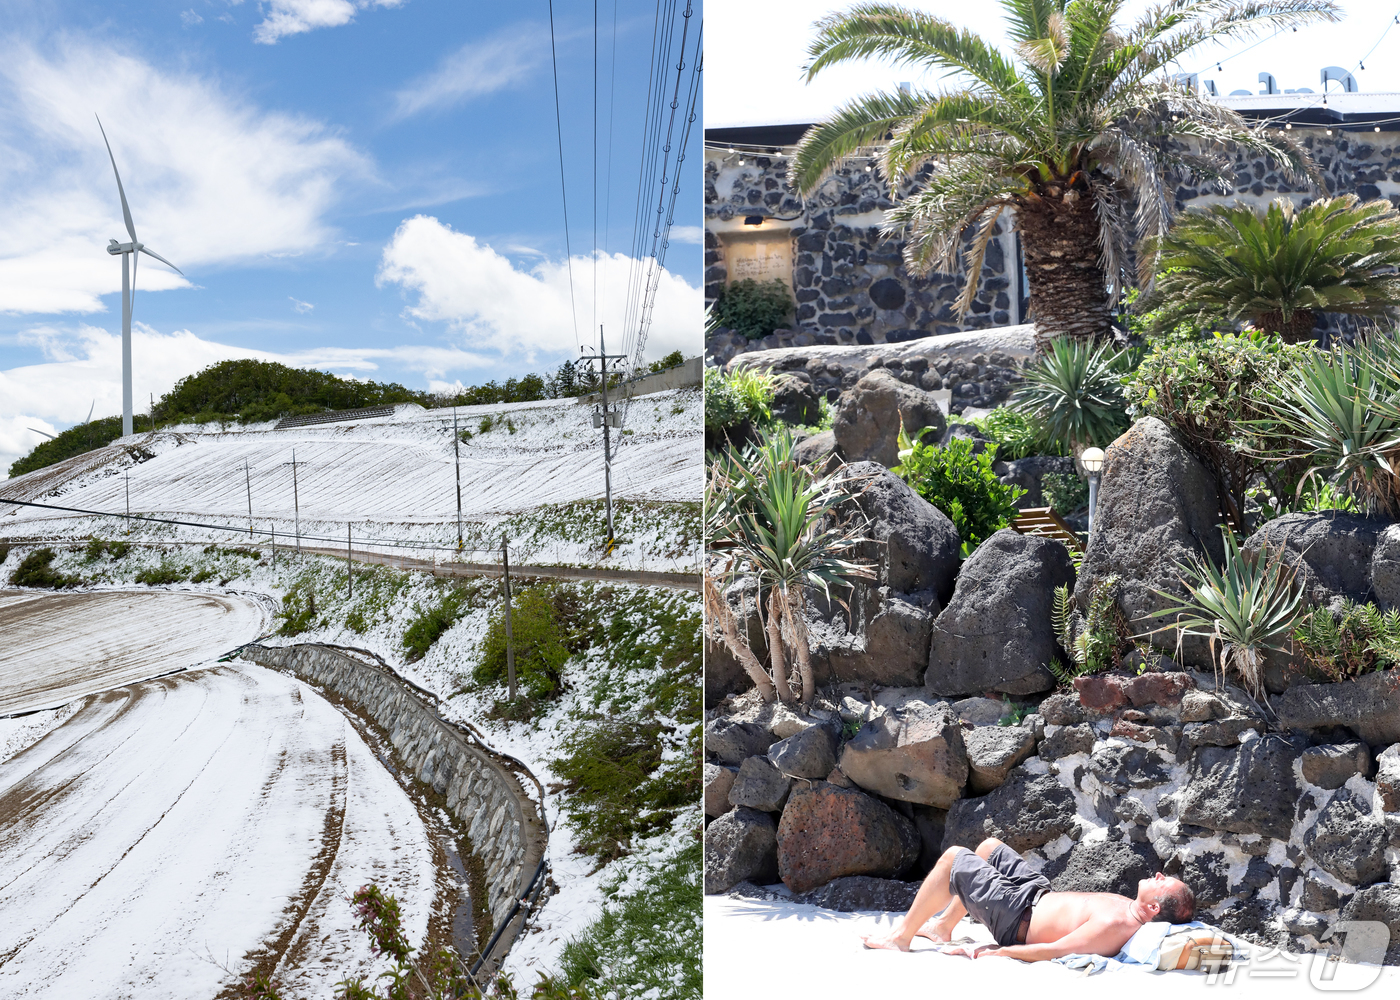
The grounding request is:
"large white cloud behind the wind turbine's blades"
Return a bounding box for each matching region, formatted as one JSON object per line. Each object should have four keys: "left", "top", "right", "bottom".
{"left": 0, "top": 41, "right": 368, "bottom": 312}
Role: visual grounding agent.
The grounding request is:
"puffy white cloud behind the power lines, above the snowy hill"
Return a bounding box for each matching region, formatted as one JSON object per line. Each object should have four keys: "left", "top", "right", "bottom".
{"left": 375, "top": 216, "right": 703, "bottom": 360}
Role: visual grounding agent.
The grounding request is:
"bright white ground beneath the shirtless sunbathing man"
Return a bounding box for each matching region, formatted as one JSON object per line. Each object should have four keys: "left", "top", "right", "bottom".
{"left": 704, "top": 896, "right": 1400, "bottom": 1000}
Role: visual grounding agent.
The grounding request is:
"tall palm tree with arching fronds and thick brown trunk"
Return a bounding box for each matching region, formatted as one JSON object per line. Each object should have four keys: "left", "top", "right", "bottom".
{"left": 790, "top": 0, "right": 1338, "bottom": 343}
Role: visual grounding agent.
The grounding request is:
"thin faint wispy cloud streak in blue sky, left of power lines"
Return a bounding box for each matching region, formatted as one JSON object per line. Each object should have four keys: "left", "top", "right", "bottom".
{"left": 395, "top": 24, "right": 546, "bottom": 119}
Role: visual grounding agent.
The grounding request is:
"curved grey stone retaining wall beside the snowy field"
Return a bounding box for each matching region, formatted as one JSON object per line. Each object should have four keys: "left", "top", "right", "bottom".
{"left": 241, "top": 646, "right": 545, "bottom": 935}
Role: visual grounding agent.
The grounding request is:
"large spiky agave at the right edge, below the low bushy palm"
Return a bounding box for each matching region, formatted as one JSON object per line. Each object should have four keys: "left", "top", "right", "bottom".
{"left": 1270, "top": 336, "right": 1400, "bottom": 517}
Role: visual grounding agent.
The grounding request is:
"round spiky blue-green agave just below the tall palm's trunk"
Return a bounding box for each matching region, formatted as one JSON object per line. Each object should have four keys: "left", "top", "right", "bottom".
{"left": 1011, "top": 338, "right": 1128, "bottom": 459}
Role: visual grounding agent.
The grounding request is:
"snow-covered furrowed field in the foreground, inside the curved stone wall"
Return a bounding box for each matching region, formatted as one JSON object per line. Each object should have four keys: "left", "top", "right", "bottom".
{"left": 0, "top": 649, "right": 438, "bottom": 1000}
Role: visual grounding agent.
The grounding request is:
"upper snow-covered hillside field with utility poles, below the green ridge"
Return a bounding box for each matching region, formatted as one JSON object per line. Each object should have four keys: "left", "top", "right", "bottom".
{"left": 0, "top": 389, "right": 703, "bottom": 571}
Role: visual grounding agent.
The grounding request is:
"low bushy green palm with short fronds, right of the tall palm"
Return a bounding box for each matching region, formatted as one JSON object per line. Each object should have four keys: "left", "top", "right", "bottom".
{"left": 1151, "top": 195, "right": 1400, "bottom": 342}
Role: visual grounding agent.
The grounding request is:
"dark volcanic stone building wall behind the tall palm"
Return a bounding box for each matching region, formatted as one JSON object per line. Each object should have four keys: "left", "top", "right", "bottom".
{"left": 704, "top": 127, "right": 1400, "bottom": 354}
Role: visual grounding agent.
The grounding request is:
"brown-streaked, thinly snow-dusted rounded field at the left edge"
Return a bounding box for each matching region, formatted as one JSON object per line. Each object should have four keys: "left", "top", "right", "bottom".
{"left": 0, "top": 591, "right": 270, "bottom": 716}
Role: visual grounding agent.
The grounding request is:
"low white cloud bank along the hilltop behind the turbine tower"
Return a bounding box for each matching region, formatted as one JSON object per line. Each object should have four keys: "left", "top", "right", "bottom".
{"left": 0, "top": 324, "right": 494, "bottom": 472}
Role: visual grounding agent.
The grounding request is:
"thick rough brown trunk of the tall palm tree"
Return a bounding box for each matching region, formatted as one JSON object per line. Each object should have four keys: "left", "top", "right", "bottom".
{"left": 1016, "top": 190, "right": 1113, "bottom": 350}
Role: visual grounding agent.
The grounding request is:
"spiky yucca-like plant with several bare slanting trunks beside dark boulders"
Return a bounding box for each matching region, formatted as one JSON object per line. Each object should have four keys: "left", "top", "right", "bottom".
{"left": 704, "top": 427, "right": 874, "bottom": 704}
